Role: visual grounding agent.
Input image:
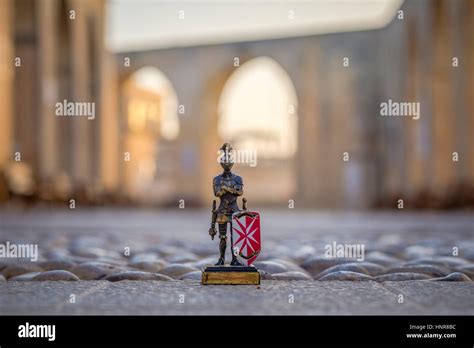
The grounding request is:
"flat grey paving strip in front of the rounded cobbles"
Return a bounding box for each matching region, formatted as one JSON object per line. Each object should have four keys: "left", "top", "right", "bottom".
{"left": 0, "top": 280, "right": 474, "bottom": 315}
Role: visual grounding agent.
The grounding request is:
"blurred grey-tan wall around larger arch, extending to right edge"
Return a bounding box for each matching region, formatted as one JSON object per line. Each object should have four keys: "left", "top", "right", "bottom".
{"left": 117, "top": 0, "right": 474, "bottom": 208}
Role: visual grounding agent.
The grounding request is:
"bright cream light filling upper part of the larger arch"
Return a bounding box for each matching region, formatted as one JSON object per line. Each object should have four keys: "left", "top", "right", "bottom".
{"left": 219, "top": 57, "right": 297, "bottom": 158}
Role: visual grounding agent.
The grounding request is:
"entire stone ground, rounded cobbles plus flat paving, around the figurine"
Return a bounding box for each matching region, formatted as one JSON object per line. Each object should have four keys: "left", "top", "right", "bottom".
{"left": 0, "top": 209, "right": 474, "bottom": 315}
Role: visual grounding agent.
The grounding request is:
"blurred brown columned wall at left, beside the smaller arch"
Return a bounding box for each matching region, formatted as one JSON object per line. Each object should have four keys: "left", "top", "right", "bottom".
{"left": 0, "top": 0, "right": 117, "bottom": 204}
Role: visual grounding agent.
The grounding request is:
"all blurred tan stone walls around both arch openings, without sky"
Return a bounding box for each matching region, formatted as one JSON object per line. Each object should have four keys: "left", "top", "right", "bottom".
{"left": 0, "top": 0, "right": 474, "bottom": 208}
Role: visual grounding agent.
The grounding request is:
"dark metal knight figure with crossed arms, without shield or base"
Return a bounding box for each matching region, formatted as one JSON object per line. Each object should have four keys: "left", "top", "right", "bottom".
{"left": 213, "top": 143, "right": 243, "bottom": 266}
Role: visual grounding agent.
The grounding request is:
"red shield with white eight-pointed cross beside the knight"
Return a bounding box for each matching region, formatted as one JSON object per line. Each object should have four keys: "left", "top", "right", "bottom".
{"left": 232, "top": 211, "right": 262, "bottom": 266}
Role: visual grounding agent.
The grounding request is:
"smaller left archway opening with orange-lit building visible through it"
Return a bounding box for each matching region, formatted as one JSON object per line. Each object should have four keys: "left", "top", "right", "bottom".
{"left": 121, "top": 66, "right": 180, "bottom": 203}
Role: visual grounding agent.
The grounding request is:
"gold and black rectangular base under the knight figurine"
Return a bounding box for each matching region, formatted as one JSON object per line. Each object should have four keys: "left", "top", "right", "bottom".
{"left": 202, "top": 266, "right": 260, "bottom": 285}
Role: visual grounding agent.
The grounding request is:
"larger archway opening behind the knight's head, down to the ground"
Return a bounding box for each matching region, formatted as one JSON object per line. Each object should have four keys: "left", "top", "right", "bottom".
{"left": 218, "top": 57, "right": 298, "bottom": 204}
